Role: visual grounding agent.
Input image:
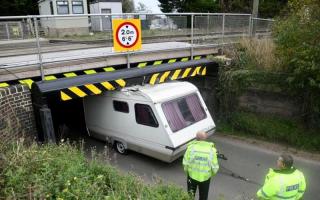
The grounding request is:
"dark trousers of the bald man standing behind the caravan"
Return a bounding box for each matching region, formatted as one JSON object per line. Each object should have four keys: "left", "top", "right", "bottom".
{"left": 187, "top": 176, "right": 210, "bottom": 200}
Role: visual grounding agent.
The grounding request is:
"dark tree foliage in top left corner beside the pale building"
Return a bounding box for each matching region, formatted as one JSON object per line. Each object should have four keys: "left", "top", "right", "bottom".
{"left": 0, "top": 0, "right": 39, "bottom": 16}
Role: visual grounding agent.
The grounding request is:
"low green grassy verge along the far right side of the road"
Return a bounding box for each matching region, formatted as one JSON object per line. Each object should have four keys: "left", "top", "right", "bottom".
{"left": 218, "top": 111, "right": 320, "bottom": 151}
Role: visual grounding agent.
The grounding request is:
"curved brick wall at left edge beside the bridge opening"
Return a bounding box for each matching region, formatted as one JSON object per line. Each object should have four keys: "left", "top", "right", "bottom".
{"left": 0, "top": 85, "right": 36, "bottom": 143}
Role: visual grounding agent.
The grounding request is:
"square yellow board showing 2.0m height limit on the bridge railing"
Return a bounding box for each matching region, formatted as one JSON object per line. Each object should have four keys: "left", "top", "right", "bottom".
{"left": 112, "top": 19, "right": 141, "bottom": 52}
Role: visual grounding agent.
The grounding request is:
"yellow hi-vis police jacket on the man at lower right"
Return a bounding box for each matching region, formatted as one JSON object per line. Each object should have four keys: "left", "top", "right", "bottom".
{"left": 257, "top": 168, "right": 306, "bottom": 200}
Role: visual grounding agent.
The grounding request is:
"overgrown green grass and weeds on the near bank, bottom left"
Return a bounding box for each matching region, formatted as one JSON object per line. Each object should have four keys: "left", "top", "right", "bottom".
{"left": 0, "top": 143, "right": 190, "bottom": 200}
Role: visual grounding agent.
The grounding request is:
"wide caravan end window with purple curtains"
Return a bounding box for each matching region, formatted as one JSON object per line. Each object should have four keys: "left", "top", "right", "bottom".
{"left": 162, "top": 94, "right": 207, "bottom": 132}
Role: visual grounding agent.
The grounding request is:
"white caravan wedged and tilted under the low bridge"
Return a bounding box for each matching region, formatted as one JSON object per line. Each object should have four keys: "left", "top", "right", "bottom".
{"left": 84, "top": 82, "right": 215, "bottom": 162}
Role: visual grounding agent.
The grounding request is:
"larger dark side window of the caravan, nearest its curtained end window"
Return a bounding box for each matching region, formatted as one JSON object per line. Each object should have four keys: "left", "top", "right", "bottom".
{"left": 134, "top": 104, "right": 159, "bottom": 127}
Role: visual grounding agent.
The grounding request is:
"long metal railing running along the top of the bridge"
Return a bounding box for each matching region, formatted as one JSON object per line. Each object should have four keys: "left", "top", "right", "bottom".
{"left": 0, "top": 13, "right": 273, "bottom": 78}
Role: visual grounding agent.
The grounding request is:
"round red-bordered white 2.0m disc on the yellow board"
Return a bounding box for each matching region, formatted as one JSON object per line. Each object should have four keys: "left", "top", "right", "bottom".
{"left": 116, "top": 22, "right": 139, "bottom": 48}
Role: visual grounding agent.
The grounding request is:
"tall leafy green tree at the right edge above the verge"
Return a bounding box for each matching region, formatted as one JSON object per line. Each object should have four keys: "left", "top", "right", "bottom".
{"left": 274, "top": 0, "right": 320, "bottom": 127}
